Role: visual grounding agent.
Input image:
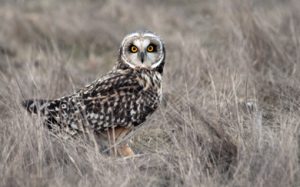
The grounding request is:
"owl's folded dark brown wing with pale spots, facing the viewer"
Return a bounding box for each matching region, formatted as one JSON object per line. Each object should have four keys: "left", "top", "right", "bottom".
{"left": 76, "top": 71, "right": 158, "bottom": 131}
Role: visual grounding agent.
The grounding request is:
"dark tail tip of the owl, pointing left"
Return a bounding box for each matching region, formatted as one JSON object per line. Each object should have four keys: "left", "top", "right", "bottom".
{"left": 22, "top": 99, "right": 51, "bottom": 114}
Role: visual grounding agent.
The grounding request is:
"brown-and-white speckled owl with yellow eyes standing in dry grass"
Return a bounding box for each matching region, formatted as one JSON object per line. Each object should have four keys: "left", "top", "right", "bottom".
{"left": 22, "top": 31, "right": 166, "bottom": 156}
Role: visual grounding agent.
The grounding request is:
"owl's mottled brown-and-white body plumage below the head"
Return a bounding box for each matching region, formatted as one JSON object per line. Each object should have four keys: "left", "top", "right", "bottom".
{"left": 23, "top": 69, "right": 162, "bottom": 134}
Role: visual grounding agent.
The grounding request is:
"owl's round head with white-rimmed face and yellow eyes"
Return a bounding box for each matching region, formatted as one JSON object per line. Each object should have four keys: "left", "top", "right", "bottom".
{"left": 120, "top": 31, "right": 165, "bottom": 71}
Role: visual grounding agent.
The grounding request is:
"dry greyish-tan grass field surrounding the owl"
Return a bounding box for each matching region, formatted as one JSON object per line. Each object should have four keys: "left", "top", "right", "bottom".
{"left": 0, "top": 0, "right": 300, "bottom": 187}
